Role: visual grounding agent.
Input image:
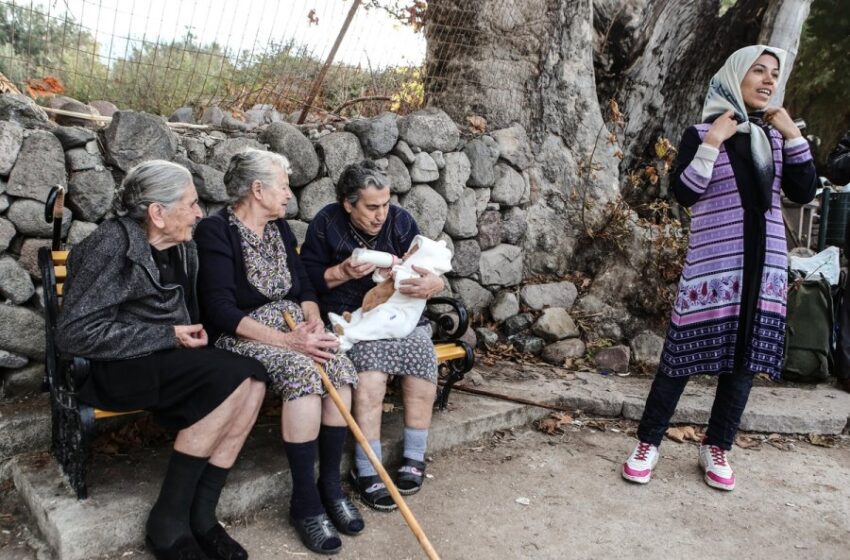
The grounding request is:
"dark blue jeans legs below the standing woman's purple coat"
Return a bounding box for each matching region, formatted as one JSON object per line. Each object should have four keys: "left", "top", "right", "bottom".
{"left": 638, "top": 372, "right": 753, "bottom": 451}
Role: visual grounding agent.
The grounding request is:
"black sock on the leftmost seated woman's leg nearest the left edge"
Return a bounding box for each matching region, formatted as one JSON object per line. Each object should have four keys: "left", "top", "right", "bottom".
{"left": 146, "top": 451, "right": 208, "bottom": 548}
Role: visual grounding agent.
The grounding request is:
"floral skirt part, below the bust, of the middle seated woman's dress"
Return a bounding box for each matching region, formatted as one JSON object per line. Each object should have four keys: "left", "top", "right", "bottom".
{"left": 215, "top": 299, "right": 357, "bottom": 401}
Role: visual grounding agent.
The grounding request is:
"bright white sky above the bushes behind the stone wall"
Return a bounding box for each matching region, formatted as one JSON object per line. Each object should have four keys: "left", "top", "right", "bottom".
{"left": 39, "top": 0, "right": 425, "bottom": 69}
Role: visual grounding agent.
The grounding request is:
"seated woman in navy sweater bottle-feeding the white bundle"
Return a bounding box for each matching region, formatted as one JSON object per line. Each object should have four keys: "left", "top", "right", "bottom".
{"left": 301, "top": 161, "right": 443, "bottom": 511}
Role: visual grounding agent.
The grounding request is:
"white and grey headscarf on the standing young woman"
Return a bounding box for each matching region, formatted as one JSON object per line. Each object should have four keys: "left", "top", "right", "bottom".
{"left": 702, "top": 45, "right": 785, "bottom": 197}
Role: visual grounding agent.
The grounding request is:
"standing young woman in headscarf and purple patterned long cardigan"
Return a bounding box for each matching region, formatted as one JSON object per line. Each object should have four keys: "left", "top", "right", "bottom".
{"left": 622, "top": 45, "right": 817, "bottom": 491}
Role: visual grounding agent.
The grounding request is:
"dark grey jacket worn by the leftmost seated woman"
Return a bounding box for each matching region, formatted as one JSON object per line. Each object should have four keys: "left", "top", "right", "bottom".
{"left": 56, "top": 218, "right": 193, "bottom": 360}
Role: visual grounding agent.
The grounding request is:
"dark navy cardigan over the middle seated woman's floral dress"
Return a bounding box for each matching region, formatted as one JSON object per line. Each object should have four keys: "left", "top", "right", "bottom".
{"left": 195, "top": 208, "right": 316, "bottom": 345}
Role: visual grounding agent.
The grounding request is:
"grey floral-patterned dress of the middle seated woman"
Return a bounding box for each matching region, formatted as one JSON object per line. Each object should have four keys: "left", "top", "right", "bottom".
{"left": 215, "top": 211, "right": 357, "bottom": 401}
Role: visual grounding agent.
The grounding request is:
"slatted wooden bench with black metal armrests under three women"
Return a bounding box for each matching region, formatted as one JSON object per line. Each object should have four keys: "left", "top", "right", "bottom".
{"left": 38, "top": 187, "right": 475, "bottom": 500}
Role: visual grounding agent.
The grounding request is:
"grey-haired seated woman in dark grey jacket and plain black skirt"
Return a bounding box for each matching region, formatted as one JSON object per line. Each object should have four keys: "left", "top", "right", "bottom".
{"left": 57, "top": 160, "right": 266, "bottom": 560}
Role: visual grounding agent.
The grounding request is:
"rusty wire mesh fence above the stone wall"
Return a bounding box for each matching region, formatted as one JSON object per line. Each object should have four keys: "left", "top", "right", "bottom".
{"left": 0, "top": 0, "right": 500, "bottom": 122}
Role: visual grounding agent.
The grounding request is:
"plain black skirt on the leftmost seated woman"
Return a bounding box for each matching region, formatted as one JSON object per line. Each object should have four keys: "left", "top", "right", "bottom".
{"left": 78, "top": 348, "right": 267, "bottom": 430}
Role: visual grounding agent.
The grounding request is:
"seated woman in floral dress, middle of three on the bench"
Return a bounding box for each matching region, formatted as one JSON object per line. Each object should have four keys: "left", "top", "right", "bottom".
{"left": 196, "top": 150, "right": 364, "bottom": 554}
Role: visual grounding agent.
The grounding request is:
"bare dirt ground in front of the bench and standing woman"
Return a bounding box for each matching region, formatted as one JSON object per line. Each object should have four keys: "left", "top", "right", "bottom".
{"left": 0, "top": 422, "right": 850, "bottom": 560}
